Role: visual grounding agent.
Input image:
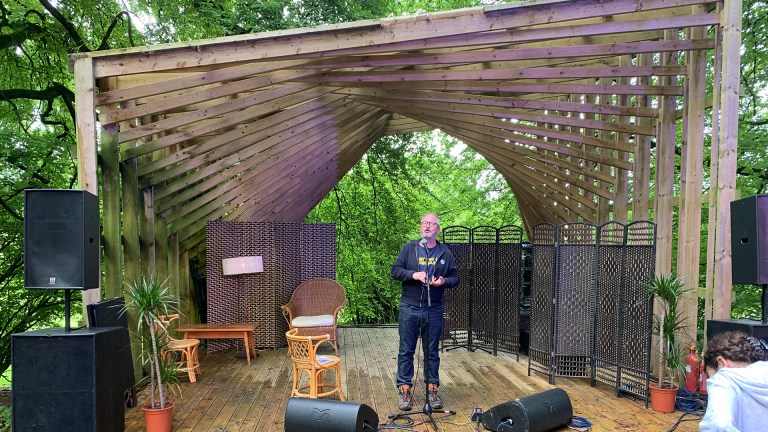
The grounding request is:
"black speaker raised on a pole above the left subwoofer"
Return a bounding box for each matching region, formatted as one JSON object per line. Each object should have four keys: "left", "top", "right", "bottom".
{"left": 24, "top": 189, "right": 100, "bottom": 289}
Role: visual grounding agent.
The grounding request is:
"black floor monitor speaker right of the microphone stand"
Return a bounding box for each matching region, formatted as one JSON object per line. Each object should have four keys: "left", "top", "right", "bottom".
{"left": 481, "top": 388, "right": 573, "bottom": 432}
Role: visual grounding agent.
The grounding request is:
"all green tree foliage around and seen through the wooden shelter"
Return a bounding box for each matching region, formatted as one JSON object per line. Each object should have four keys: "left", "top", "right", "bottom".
{"left": 0, "top": 0, "right": 768, "bottom": 382}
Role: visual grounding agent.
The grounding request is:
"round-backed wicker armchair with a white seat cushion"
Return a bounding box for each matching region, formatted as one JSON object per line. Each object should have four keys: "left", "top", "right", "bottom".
{"left": 280, "top": 278, "right": 347, "bottom": 354}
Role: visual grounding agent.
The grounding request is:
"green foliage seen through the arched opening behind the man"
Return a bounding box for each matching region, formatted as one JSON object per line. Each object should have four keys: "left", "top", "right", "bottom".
{"left": 306, "top": 132, "right": 522, "bottom": 324}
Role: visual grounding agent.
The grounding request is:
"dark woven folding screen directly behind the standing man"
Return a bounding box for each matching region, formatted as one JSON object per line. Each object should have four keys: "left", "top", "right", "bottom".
{"left": 442, "top": 225, "right": 523, "bottom": 358}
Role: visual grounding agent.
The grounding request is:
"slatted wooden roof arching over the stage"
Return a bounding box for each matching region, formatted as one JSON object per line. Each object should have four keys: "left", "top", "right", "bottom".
{"left": 72, "top": 0, "right": 720, "bottom": 251}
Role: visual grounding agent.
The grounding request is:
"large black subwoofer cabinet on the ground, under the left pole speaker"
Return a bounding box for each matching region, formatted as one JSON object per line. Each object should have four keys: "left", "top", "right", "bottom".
{"left": 11, "top": 327, "right": 125, "bottom": 432}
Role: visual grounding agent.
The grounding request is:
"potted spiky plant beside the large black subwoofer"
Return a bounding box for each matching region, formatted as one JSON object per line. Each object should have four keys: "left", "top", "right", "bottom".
{"left": 124, "top": 275, "right": 179, "bottom": 432}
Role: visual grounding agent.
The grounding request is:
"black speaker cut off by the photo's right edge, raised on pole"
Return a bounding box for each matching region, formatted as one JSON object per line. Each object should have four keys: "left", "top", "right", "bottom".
{"left": 731, "top": 195, "right": 768, "bottom": 285}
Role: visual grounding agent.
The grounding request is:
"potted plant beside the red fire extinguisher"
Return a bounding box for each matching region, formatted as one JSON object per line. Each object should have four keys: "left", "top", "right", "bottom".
{"left": 648, "top": 273, "right": 688, "bottom": 412}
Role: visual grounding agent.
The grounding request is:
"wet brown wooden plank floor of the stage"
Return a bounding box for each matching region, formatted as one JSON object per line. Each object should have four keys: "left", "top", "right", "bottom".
{"left": 125, "top": 327, "right": 698, "bottom": 432}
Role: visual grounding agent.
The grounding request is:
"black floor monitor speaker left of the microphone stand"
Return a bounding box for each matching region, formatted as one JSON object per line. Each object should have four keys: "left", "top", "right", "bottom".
{"left": 285, "top": 397, "right": 379, "bottom": 432}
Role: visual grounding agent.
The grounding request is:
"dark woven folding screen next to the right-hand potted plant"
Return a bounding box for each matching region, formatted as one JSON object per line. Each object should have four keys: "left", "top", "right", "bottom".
{"left": 528, "top": 221, "right": 656, "bottom": 403}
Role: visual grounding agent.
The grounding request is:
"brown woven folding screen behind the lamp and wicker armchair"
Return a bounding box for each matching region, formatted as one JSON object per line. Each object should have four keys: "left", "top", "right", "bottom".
{"left": 206, "top": 221, "right": 336, "bottom": 351}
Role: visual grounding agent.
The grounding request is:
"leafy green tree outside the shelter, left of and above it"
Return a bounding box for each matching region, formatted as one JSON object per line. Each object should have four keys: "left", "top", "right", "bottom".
{"left": 0, "top": 0, "right": 392, "bottom": 378}
